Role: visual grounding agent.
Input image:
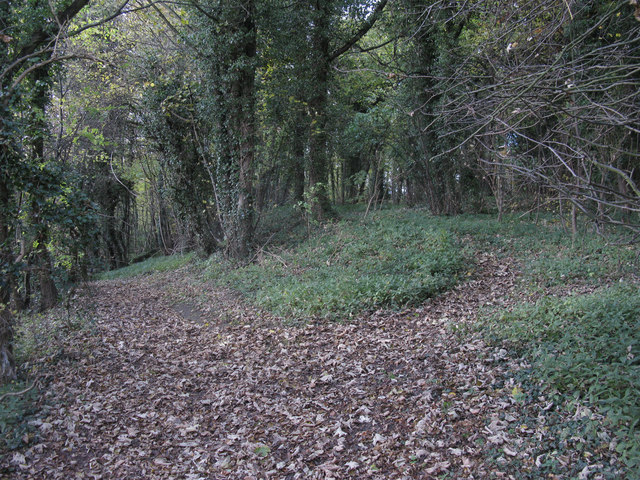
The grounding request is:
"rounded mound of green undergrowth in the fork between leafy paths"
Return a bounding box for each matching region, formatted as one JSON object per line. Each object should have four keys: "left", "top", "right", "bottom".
{"left": 204, "top": 209, "right": 469, "bottom": 319}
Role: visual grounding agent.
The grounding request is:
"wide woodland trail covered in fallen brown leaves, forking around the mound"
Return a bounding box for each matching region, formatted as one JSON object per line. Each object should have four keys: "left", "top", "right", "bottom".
{"left": 3, "top": 255, "right": 535, "bottom": 480}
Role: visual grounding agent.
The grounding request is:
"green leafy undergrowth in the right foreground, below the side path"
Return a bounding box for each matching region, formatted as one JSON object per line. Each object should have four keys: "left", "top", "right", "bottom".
{"left": 484, "top": 284, "right": 640, "bottom": 478}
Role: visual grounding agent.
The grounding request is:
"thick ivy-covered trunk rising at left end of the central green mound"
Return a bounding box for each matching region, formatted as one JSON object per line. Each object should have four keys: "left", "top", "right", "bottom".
{"left": 203, "top": 0, "right": 256, "bottom": 258}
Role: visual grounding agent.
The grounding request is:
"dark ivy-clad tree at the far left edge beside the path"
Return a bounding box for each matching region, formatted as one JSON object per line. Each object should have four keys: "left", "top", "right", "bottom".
{"left": 0, "top": 0, "right": 107, "bottom": 380}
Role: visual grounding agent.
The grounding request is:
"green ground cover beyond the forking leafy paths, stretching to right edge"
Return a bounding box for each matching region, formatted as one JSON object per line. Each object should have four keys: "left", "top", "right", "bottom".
{"left": 205, "top": 206, "right": 638, "bottom": 319}
